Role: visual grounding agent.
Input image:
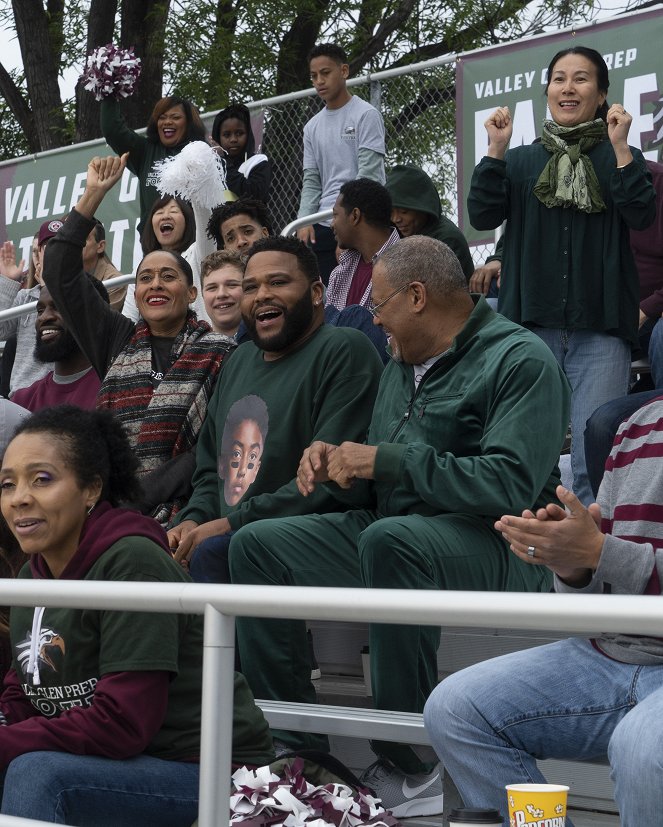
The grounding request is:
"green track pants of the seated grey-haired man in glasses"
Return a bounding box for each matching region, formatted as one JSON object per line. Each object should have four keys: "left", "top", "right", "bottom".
{"left": 230, "top": 511, "right": 550, "bottom": 772}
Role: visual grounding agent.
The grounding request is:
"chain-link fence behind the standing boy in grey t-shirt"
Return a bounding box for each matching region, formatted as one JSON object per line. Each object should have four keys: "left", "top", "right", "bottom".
{"left": 249, "top": 57, "right": 493, "bottom": 264}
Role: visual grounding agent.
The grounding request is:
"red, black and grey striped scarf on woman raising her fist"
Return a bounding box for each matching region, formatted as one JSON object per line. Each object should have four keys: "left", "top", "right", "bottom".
{"left": 97, "top": 311, "right": 234, "bottom": 523}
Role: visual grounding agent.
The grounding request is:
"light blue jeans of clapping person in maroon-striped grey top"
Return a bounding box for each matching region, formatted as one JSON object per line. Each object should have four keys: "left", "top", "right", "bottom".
{"left": 424, "top": 638, "right": 663, "bottom": 827}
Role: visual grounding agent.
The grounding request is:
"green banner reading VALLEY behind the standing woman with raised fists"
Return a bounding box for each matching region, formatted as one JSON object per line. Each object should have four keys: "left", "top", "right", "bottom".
{"left": 456, "top": 10, "right": 663, "bottom": 244}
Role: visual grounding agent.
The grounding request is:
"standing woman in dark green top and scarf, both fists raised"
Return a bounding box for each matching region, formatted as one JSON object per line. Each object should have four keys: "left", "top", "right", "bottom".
{"left": 467, "top": 46, "right": 656, "bottom": 505}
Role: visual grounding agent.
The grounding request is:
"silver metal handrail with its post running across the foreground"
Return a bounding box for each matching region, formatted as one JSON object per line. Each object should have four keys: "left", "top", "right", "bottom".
{"left": 0, "top": 580, "right": 663, "bottom": 827}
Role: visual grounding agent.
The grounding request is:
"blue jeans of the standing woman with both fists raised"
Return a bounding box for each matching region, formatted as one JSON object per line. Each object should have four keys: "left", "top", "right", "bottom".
{"left": 532, "top": 327, "right": 631, "bottom": 505}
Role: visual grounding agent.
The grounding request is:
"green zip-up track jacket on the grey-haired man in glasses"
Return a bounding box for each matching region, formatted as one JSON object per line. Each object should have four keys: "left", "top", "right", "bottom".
{"left": 337, "top": 295, "right": 570, "bottom": 522}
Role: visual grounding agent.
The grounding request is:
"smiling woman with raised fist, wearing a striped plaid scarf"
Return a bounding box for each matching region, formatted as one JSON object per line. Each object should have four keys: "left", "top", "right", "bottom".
{"left": 44, "top": 155, "right": 233, "bottom": 523}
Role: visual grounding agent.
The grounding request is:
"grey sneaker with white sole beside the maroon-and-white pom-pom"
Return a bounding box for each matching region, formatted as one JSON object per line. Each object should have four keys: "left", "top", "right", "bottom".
{"left": 360, "top": 758, "right": 443, "bottom": 818}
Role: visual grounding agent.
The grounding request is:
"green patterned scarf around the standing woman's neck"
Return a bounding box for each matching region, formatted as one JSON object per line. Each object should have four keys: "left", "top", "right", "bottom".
{"left": 534, "top": 118, "right": 607, "bottom": 213}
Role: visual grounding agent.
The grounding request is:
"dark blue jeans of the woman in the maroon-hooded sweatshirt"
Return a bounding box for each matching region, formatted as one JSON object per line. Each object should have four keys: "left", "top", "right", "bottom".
{"left": 2, "top": 752, "right": 200, "bottom": 827}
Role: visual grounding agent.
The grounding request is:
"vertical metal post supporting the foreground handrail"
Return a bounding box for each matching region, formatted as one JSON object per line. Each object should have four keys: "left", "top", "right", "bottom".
{"left": 198, "top": 604, "right": 235, "bottom": 827}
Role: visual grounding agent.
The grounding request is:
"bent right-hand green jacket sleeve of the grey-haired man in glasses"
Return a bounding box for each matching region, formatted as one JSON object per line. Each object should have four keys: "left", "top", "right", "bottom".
{"left": 375, "top": 351, "right": 570, "bottom": 515}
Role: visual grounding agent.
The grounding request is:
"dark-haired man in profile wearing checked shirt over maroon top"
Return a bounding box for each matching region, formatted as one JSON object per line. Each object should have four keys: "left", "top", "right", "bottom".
{"left": 325, "top": 178, "right": 400, "bottom": 310}
